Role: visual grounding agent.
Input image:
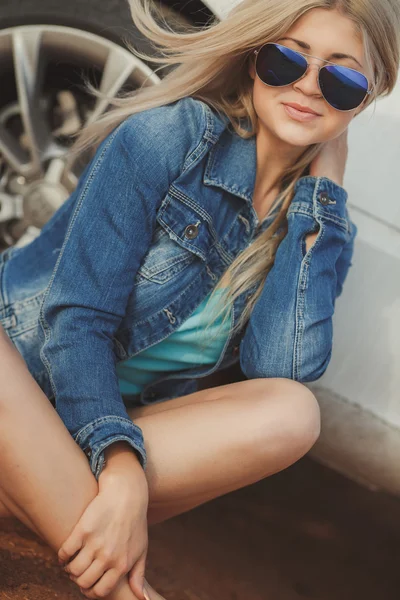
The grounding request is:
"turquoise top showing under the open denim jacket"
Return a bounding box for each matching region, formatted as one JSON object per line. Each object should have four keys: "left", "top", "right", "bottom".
{"left": 117, "top": 289, "right": 231, "bottom": 394}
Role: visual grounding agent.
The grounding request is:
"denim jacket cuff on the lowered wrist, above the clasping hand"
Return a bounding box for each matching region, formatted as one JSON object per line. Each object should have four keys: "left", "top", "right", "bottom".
{"left": 73, "top": 415, "right": 147, "bottom": 481}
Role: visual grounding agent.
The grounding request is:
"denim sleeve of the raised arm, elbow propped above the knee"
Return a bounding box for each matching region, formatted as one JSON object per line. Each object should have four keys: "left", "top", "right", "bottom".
{"left": 240, "top": 176, "right": 357, "bottom": 382}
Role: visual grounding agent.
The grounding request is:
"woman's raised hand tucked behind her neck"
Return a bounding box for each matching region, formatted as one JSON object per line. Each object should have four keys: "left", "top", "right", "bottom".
{"left": 310, "top": 128, "right": 348, "bottom": 186}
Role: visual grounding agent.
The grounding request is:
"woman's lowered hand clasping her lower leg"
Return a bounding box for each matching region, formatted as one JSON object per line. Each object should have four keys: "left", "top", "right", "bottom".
{"left": 58, "top": 443, "right": 148, "bottom": 600}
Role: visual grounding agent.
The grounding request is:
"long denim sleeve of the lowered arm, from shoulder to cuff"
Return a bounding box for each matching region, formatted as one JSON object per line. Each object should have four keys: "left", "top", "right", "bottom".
{"left": 39, "top": 99, "right": 204, "bottom": 479}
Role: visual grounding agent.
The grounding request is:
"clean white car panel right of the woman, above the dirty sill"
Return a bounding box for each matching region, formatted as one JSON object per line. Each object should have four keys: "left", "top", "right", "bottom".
{"left": 318, "top": 85, "right": 400, "bottom": 427}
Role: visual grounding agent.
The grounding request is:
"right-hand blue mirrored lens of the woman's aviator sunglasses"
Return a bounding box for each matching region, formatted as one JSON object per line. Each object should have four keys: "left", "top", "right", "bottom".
{"left": 319, "top": 65, "right": 368, "bottom": 110}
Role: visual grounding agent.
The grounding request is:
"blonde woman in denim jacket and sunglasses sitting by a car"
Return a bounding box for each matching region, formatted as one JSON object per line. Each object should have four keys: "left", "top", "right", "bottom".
{"left": 0, "top": 0, "right": 400, "bottom": 600}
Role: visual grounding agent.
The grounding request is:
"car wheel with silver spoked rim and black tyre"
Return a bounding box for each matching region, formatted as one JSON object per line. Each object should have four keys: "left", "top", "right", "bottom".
{"left": 0, "top": 0, "right": 189, "bottom": 250}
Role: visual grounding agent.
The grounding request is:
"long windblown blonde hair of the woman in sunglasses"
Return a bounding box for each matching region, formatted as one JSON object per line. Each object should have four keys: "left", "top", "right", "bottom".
{"left": 70, "top": 0, "right": 400, "bottom": 344}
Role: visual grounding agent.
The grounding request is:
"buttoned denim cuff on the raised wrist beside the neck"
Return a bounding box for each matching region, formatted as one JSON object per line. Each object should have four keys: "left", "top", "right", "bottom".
{"left": 288, "top": 175, "right": 350, "bottom": 232}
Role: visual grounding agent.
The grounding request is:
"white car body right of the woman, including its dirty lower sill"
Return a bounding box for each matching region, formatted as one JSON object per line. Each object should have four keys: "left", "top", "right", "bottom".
{"left": 207, "top": 0, "right": 400, "bottom": 495}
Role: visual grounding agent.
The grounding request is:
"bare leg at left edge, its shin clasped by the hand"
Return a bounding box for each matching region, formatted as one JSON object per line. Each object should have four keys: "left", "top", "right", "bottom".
{"left": 0, "top": 327, "right": 152, "bottom": 600}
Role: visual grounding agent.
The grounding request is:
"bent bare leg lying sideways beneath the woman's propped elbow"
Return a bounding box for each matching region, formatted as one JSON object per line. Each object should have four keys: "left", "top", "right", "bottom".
{"left": 0, "top": 379, "right": 319, "bottom": 535}
